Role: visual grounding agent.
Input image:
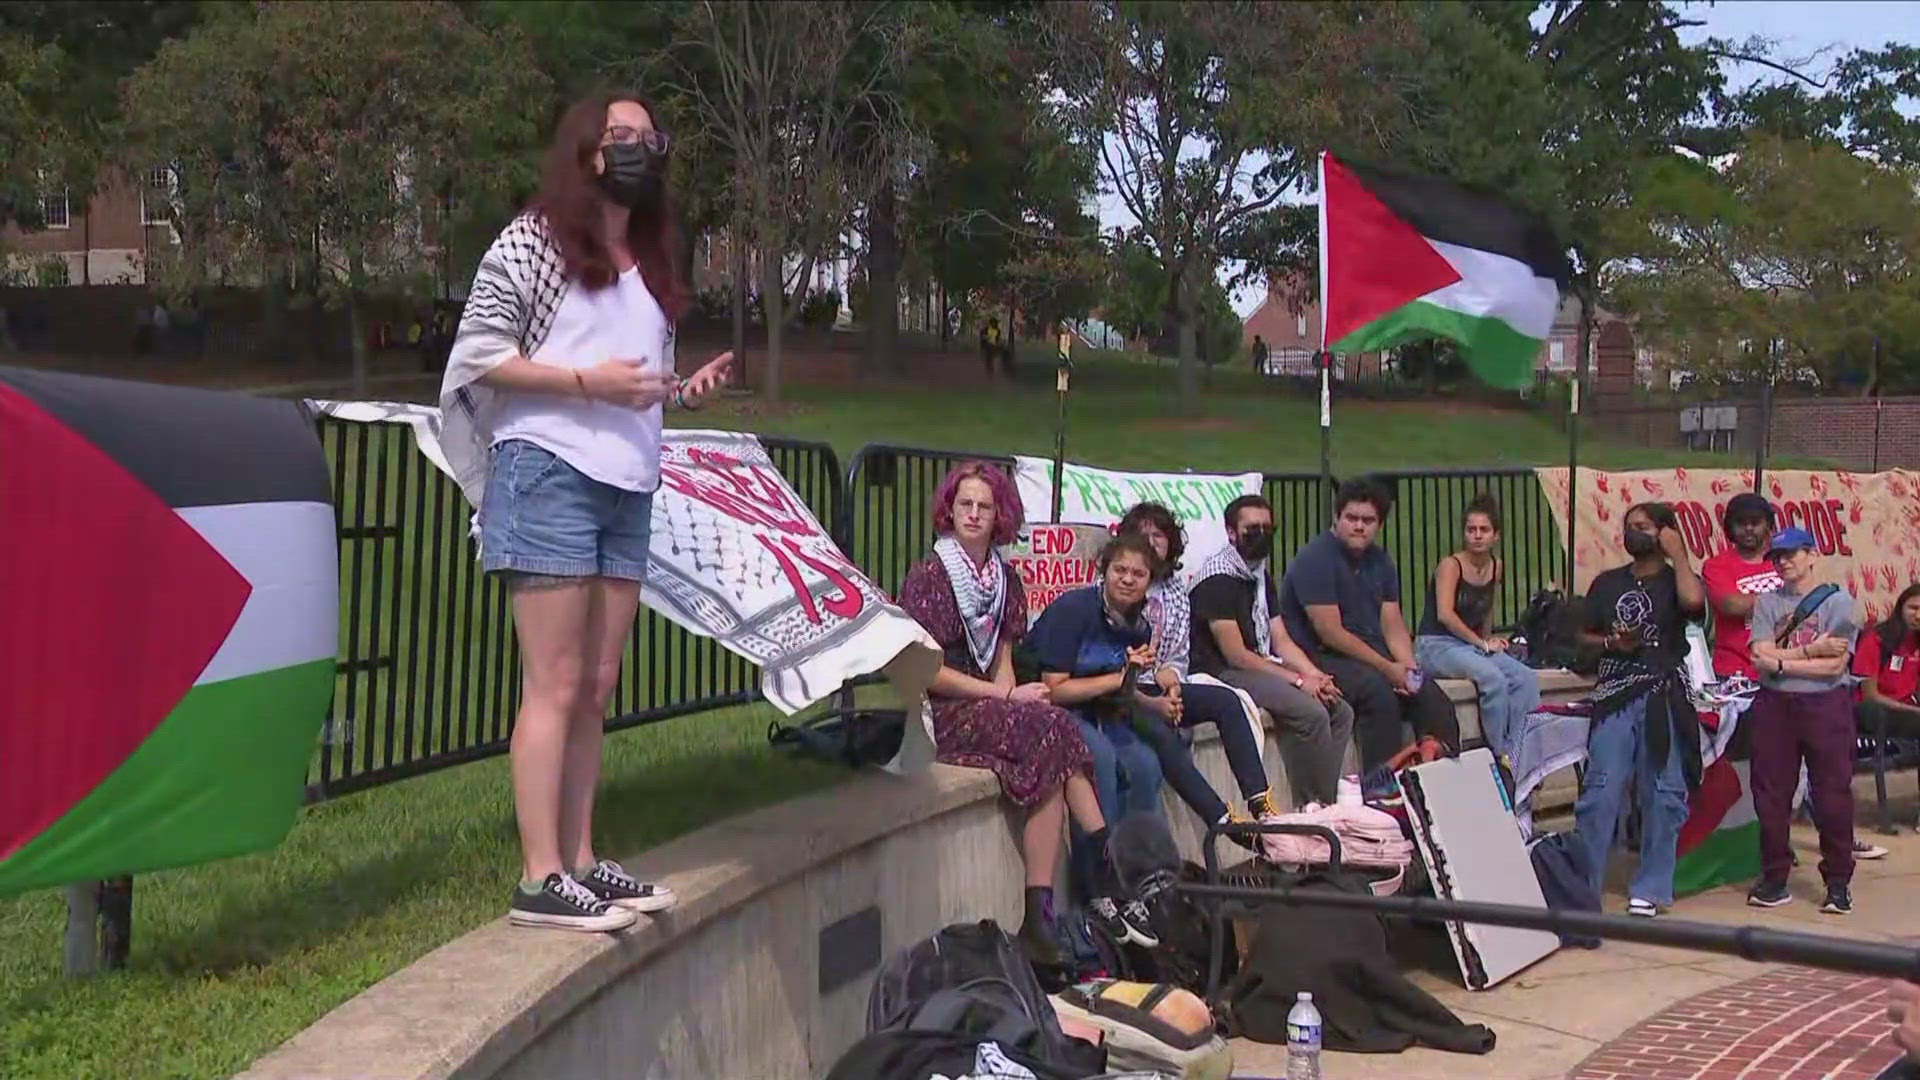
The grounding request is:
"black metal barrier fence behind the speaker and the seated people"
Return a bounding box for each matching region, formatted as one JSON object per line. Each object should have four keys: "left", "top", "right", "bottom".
{"left": 307, "top": 426, "right": 1561, "bottom": 801}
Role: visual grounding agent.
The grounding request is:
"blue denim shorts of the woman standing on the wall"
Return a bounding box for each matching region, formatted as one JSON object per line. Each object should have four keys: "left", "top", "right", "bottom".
{"left": 480, "top": 438, "right": 653, "bottom": 580}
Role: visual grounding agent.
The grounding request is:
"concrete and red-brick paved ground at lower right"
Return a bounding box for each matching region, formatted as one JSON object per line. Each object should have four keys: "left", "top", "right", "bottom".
{"left": 1235, "top": 771, "right": 1920, "bottom": 1080}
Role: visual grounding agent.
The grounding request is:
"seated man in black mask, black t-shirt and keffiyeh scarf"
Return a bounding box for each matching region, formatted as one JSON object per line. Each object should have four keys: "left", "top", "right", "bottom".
{"left": 1188, "top": 496, "right": 1354, "bottom": 803}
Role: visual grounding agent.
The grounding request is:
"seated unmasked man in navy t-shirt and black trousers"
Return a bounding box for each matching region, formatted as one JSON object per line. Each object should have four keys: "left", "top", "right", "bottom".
{"left": 1281, "top": 479, "right": 1459, "bottom": 799}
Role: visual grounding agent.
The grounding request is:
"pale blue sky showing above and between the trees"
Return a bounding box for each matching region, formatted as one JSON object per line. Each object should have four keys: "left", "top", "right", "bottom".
{"left": 1098, "top": 0, "right": 1920, "bottom": 317}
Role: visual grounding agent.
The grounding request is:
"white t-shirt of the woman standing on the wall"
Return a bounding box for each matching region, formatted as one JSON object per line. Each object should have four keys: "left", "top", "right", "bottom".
{"left": 493, "top": 267, "right": 674, "bottom": 492}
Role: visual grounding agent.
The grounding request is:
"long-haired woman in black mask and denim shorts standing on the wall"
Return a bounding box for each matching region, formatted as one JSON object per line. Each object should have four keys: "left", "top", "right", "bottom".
{"left": 440, "top": 94, "right": 733, "bottom": 930}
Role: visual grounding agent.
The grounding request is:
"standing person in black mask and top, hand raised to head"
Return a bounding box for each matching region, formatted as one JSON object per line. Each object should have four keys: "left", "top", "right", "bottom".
{"left": 1572, "top": 503, "right": 1707, "bottom": 919}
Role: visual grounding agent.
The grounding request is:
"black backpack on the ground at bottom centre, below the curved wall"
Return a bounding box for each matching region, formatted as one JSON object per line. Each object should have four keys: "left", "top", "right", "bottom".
{"left": 864, "top": 919, "right": 1106, "bottom": 1076}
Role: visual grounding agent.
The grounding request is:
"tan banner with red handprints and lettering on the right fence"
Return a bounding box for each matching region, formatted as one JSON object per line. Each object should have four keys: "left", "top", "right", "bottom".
{"left": 1534, "top": 469, "right": 1920, "bottom": 621}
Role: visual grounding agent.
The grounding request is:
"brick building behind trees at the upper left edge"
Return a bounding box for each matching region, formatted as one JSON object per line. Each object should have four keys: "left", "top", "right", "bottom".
{"left": 0, "top": 169, "right": 179, "bottom": 284}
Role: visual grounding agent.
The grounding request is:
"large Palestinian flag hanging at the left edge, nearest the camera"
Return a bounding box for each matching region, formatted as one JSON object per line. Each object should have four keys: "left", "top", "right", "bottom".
{"left": 0, "top": 367, "right": 340, "bottom": 896}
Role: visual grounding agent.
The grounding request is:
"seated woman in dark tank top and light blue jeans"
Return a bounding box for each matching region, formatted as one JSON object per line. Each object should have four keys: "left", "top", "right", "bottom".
{"left": 1413, "top": 492, "right": 1540, "bottom": 765}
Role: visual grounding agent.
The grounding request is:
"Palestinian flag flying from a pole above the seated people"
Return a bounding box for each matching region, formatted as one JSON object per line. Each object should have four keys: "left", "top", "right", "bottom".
{"left": 1319, "top": 152, "right": 1572, "bottom": 388}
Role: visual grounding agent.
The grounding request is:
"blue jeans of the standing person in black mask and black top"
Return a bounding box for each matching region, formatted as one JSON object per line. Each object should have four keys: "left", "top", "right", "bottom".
{"left": 1572, "top": 696, "right": 1688, "bottom": 907}
